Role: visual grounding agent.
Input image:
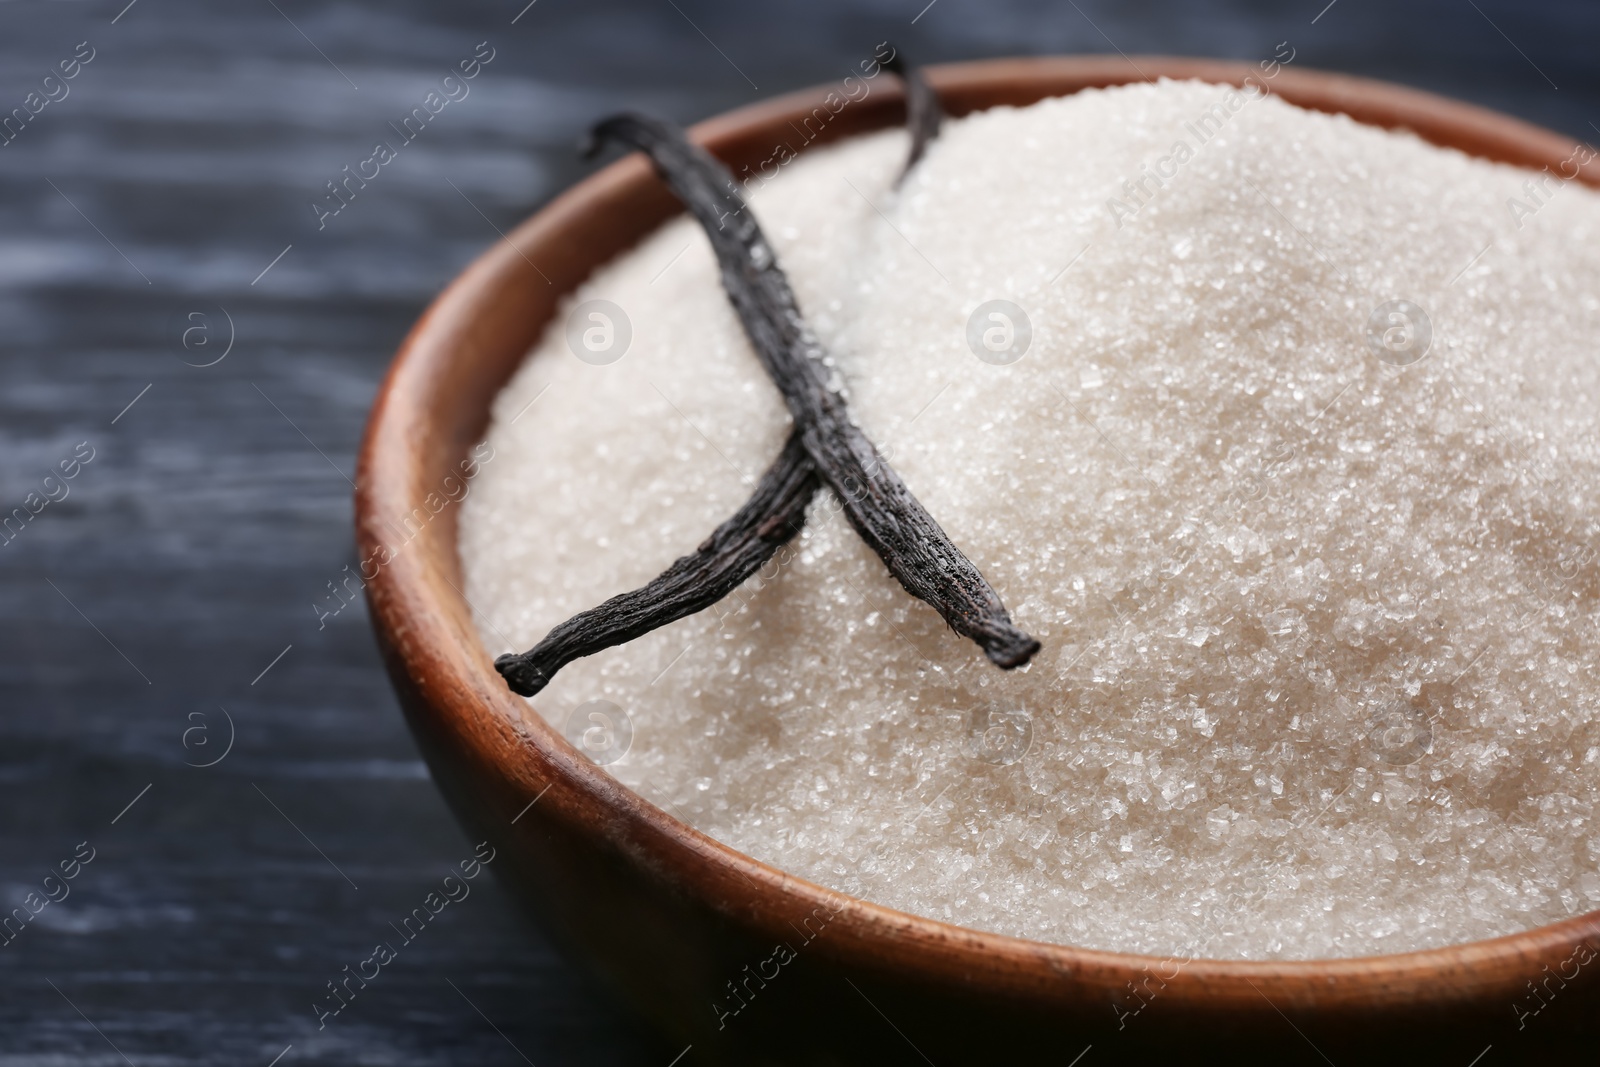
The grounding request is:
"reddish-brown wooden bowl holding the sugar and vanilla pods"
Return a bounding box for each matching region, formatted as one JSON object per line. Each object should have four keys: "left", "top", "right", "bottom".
{"left": 355, "top": 56, "right": 1600, "bottom": 1067}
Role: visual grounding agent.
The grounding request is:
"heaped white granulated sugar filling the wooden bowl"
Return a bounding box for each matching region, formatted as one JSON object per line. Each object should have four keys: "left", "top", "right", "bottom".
{"left": 461, "top": 82, "right": 1600, "bottom": 958}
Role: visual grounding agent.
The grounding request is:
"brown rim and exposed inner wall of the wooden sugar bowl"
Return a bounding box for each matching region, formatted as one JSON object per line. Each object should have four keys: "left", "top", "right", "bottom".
{"left": 357, "top": 56, "right": 1600, "bottom": 1005}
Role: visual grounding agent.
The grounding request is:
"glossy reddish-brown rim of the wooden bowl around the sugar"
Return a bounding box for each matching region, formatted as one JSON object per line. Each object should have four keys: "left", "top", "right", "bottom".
{"left": 355, "top": 56, "right": 1600, "bottom": 1011}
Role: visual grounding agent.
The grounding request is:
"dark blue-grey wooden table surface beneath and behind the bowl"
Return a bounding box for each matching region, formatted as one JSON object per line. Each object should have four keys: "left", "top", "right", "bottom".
{"left": 0, "top": 0, "right": 1600, "bottom": 1067}
